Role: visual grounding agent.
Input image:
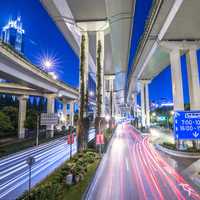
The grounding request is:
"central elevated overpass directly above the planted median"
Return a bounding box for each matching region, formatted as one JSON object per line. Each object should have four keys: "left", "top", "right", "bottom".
{"left": 41, "top": 0, "right": 135, "bottom": 110}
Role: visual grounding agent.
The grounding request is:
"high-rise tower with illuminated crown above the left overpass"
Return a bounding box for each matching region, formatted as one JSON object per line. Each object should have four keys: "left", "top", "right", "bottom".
{"left": 1, "top": 16, "right": 25, "bottom": 53}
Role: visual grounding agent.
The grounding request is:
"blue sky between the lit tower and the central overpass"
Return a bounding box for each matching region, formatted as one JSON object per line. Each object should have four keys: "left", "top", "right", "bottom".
{"left": 0, "top": 0, "right": 79, "bottom": 87}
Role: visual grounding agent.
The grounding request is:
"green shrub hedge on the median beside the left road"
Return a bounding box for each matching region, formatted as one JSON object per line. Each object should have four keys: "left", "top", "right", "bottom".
{"left": 18, "top": 150, "right": 99, "bottom": 200}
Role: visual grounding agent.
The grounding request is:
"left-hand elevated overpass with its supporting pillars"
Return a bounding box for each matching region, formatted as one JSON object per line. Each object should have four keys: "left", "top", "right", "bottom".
{"left": 0, "top": 42, "right": 79, "bottom": 139}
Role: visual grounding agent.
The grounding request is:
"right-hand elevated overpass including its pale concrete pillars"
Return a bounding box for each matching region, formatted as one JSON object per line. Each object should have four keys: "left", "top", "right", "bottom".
{"left": 127, "top": 0, "right": 200, "bottom": 130}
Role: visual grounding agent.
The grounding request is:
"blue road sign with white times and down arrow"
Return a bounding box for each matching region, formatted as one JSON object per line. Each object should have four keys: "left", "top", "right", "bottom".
{"left": 174, "top": 111, "right": 200, "bottom": 140}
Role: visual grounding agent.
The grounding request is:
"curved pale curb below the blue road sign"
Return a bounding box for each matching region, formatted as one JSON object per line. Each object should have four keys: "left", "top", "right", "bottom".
{"left": 154, "top": 144, "right": 200, "bottom": 158}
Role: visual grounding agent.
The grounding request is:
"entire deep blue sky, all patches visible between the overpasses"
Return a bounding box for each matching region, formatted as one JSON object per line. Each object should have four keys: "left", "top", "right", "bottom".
{"left": 0, "top": 0, "right": 200, "bottom": 102}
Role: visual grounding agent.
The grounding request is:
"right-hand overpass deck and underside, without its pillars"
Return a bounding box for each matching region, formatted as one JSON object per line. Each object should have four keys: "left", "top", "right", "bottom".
{"left": 128, "top": 0, "right": 200, "bottom": 99}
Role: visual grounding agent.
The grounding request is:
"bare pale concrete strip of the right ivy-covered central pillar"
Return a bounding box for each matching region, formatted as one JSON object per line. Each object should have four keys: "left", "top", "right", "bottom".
{"left": 96, "top": 31, "right": 105, "bottom": 117}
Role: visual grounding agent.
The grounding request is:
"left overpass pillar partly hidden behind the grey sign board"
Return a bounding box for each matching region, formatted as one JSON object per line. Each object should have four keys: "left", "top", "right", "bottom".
{"left": 47, "top": 95, "right": 55, "bottom": 138}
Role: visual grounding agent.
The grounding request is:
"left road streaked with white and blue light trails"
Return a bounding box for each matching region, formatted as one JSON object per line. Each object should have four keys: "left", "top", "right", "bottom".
{"left": 0, "top": 129, "right": 95, "bottom": 200}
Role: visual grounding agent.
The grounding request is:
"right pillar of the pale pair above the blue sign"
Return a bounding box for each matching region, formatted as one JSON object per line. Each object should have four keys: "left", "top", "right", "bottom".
{"left": 186, "top": 48, "right": 200, "bottom": 110}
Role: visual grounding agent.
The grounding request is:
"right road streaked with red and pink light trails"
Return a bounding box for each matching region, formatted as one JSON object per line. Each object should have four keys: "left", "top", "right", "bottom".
{"left": 85, "top": 125, "right": 200, "bottom": 200}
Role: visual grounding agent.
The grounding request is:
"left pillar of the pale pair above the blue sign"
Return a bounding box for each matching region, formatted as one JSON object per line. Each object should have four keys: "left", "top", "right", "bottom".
{"left": 170, "top": 48, "right": 184, "bottom": 111}
